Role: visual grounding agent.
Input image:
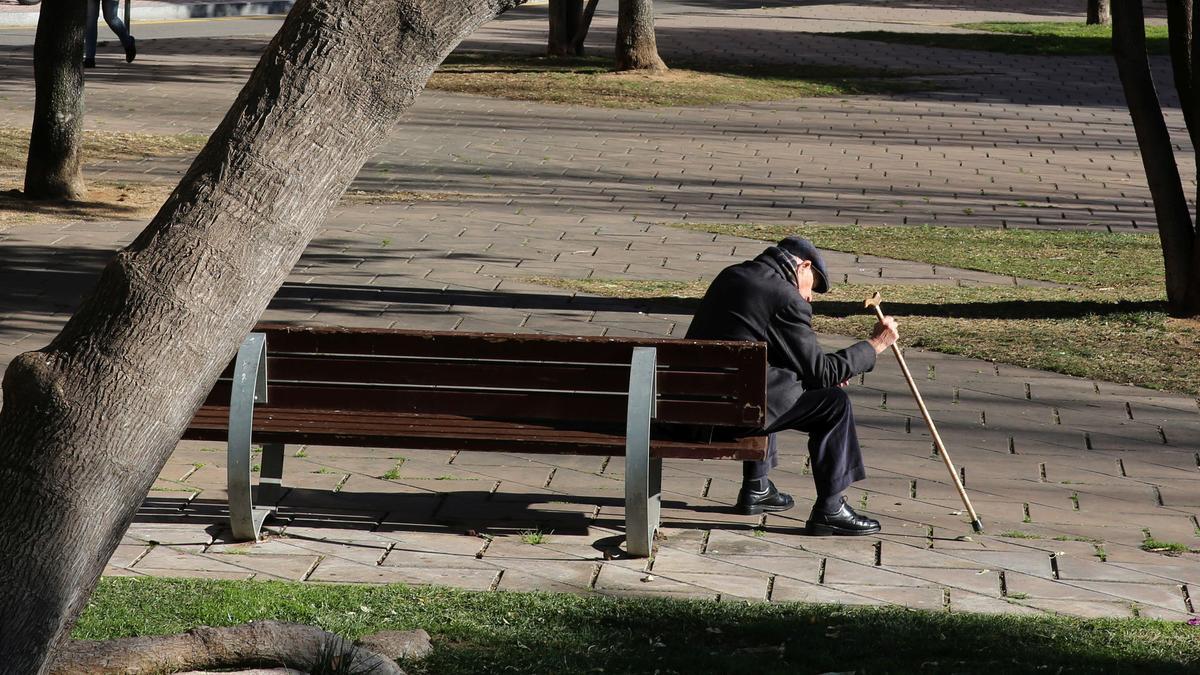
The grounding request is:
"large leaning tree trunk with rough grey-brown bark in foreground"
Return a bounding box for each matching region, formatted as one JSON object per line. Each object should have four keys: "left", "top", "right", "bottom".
{"left": 0, "top": 0, "right": 520, "bottom": 675}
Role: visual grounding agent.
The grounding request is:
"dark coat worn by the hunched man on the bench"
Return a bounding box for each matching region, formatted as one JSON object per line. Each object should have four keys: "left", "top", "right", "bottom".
{"left": 686, "top": 246, "right": 875, "bottom": 426}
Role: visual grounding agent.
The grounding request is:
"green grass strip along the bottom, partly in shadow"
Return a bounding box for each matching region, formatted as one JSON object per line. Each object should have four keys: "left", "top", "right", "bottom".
{"left": 74, "top": 578, "right": 1200, "bottom": 675}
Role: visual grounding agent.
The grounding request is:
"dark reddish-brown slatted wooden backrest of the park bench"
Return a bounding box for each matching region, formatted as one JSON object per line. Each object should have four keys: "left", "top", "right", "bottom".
{"left": 205, "top": 324, "right": 767, "bottom": 428}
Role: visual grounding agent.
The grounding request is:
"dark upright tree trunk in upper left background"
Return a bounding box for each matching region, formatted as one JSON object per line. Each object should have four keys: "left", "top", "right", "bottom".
{"left": 25, "top": 0, "right": 88, "bottom": 199}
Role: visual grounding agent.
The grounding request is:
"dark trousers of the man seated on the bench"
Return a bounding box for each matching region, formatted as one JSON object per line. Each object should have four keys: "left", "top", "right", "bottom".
{"left": 742, "top": 387, "right": 866, "bottom": 497}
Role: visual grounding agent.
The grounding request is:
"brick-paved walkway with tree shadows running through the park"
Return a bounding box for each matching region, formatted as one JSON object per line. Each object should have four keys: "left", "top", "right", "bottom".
{"left": 0, "top": 2, "right": 1200, "bottom": 620}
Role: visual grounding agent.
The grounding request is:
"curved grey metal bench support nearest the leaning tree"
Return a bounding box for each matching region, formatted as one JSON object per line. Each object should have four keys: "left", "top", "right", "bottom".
{"left": 227, "top": 333, "right": 274, "bottom": 542}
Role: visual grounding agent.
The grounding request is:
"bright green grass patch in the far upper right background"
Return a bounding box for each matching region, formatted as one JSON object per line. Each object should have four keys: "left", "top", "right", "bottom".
{"left": 833, "top": 22, "right": 1168, "bottom": 56}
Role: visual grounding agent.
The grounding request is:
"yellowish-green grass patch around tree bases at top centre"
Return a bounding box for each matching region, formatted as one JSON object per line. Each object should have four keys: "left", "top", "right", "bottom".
{"left": 428, "top": 52, "right": 934, "bottom": 108}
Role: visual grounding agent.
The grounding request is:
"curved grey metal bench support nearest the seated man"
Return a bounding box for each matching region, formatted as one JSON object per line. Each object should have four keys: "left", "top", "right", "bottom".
{"left": 625, "top": 347, "right": 662, "bottom": 557}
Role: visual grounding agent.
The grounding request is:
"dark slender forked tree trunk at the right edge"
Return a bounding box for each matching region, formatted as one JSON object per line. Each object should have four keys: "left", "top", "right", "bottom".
{"left": 1112, "top": 0, "right": 1200, "bottom": 316}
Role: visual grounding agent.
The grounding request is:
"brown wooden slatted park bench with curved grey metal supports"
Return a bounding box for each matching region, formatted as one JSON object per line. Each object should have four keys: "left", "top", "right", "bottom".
{"left": 184, "top": 324, "right": 767, "bottom": 556}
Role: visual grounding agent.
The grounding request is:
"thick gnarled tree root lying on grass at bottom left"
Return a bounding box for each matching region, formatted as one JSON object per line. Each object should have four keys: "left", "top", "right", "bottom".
{"left": 50, "top": 621, "right": 404, "bottom": 675}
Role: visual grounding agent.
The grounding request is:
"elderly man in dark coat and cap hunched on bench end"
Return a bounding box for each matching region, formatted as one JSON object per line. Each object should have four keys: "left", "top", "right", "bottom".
{"left": 688, "top": 237, "right": 899, "bottom": 534}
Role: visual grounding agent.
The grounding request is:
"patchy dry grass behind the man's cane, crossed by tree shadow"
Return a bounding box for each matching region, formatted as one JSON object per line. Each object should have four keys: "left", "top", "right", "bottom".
{"left": 534, "top": 225, "right": 1200, "bottom": 394}
